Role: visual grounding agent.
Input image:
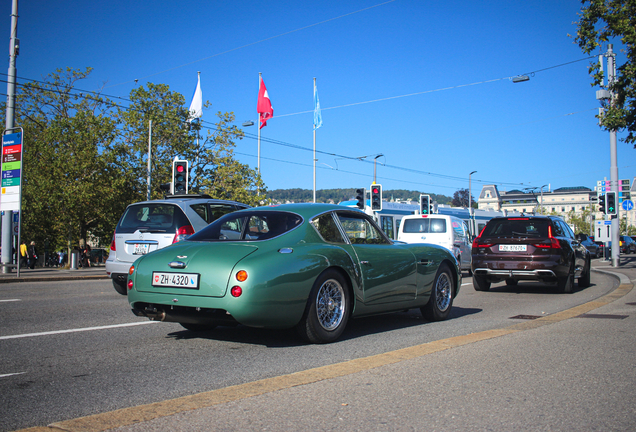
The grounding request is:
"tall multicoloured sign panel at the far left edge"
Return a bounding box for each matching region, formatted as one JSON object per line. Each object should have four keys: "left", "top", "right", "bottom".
{"left": 0, "top": 132, "right": 22, "bottom": 211}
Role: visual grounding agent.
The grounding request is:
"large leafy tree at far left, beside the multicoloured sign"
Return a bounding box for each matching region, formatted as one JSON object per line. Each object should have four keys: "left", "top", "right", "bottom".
{"left": 16, "top": 68, "right": 128, "bottom": 253}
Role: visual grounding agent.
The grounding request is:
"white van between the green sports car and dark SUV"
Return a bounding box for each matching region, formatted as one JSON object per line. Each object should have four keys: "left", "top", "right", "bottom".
{"left": 398, "top": 214, "right": 472, "bottom": 271}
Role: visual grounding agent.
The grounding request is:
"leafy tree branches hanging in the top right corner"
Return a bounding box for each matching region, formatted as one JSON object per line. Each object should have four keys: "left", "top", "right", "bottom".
{"left": 575, "top": 0, "right": 636, "bottom": 148}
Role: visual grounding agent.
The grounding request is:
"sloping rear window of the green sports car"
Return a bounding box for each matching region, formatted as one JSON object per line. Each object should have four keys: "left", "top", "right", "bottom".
{"left": 187, "top": 210, "right": 303, "bottom": 241}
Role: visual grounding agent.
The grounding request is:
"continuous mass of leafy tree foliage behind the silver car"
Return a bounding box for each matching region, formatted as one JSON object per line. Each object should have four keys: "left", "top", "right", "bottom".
{"left": 15, "top": 68, "right": 266, "bottom": 253}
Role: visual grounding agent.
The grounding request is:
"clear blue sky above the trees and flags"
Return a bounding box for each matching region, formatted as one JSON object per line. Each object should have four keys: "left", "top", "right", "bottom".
{"left": 0, "top": 0, "right": 636, "bottom": 196}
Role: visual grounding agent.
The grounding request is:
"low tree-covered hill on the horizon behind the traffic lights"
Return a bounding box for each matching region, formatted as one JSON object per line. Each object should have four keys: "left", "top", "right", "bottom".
{"left": 267, "top": 189, "right": 452, "bottom": 204}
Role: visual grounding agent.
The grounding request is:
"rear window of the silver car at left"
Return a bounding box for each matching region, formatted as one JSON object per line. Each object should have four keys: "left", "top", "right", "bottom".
{"left": 116, "top": 204, "right": 190, "bottom": 234}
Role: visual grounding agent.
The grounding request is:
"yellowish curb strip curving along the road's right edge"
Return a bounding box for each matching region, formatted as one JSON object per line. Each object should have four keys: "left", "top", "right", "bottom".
{"left": 21, "top": 284, "right": 633, "bottom": 432}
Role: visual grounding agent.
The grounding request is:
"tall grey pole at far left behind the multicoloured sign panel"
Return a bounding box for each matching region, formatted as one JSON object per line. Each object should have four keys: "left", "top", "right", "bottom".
{"left": 2, "top": 0, "right": 22, "bottom": 273}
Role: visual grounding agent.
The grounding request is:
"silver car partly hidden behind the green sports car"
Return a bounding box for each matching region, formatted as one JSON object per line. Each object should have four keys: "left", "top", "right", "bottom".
{"left": 106, "top": 195, "right": 250, "bottom": 295}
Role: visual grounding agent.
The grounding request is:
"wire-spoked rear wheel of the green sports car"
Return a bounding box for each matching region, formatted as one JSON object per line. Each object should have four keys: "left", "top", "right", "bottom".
{"left": 296, "top": 269, "right": 351, "bottom": 343}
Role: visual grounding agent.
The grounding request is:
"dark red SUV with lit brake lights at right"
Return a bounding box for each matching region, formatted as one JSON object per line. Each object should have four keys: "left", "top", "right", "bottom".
{"left": 471, "top": 216, "right": 591, "bottom": 293}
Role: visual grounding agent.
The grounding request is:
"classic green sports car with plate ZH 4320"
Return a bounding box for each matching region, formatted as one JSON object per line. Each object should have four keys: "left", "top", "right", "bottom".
{"left": 128, "top": 204, "right": 461, "bottom": 343}
